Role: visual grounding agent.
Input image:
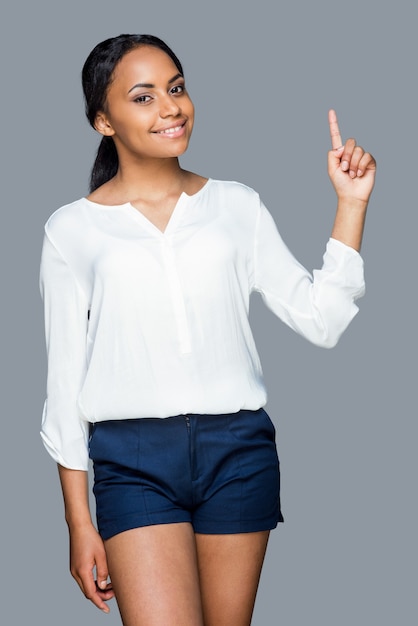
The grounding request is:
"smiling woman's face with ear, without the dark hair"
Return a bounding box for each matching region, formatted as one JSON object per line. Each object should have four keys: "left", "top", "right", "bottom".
{"left": 96, "top": 46, "right": 194, "bottom": 159}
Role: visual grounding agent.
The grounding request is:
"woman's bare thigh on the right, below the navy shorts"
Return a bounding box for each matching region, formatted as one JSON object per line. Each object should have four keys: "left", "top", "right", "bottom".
{"left": 196, "top": 531, "right": 269, "bottom": 626}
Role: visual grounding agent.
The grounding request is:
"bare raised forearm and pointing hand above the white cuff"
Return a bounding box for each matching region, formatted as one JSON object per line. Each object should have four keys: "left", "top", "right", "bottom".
{"left": 328, "top": 110, "right": 376, "bottom": 251}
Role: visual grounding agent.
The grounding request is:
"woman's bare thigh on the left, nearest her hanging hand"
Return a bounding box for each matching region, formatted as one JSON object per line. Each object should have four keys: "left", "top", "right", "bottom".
{"left": 105, "top": 523, "right": 203, "bottom": 626}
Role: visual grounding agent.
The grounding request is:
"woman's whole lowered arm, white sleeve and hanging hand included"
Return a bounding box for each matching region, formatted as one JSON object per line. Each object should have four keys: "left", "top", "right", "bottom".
{"left": 40, "top": 224, "right": 114, "bottom": 613}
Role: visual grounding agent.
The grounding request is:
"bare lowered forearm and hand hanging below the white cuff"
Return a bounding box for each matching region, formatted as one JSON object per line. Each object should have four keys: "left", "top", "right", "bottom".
{"left": 58, "top": 465, "right": 114, "bottom": 613}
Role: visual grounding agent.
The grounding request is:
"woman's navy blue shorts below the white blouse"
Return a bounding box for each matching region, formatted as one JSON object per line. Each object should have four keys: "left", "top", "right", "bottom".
{"left": 89, "top": 409, "right": 283, "bottom": 539}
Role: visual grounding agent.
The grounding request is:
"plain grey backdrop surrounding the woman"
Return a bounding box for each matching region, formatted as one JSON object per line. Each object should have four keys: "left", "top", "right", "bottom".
{"left": 0, "top": 0, "right": 418, "bottom": 626}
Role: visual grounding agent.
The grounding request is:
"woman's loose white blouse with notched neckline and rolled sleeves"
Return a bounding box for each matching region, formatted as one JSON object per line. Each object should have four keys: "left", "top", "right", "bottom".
{"left": 40, "top": 179, "right": 364, "bottom": 470}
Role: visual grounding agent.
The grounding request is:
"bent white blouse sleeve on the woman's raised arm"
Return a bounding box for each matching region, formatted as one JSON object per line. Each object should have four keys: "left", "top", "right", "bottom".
{"left": 254, "top": 204, "right": 364, "bottom": 348}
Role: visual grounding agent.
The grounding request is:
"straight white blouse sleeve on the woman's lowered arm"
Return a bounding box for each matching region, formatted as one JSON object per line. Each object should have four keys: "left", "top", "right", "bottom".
{"left": 40, "top": 234, "right": 88, "bottom": 470}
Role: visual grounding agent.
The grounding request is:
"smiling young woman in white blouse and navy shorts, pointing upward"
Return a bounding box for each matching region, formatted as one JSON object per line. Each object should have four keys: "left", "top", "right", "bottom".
{"left": 41, "top": 35, "right": 375, "bottom": 626}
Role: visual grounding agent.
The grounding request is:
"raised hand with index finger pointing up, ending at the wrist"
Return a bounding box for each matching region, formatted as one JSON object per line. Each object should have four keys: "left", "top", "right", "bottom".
{"left": 328, "top": 109, "right": 376, "bottom": 205}
